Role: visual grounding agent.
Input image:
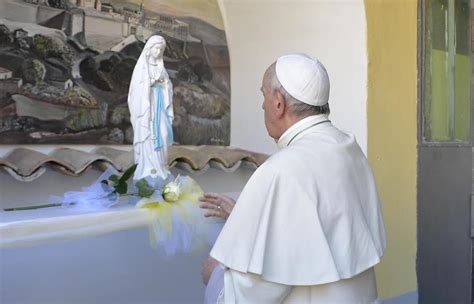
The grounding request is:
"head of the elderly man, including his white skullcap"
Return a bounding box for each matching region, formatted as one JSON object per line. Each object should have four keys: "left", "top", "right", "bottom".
{"left": 261, "top": 54, "right": 329, "bottom": 140}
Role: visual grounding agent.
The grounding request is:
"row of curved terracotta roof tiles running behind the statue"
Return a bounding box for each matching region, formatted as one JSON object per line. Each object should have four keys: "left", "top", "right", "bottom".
{"left": 0, "top": 146, "right": 268, "bottom": 181}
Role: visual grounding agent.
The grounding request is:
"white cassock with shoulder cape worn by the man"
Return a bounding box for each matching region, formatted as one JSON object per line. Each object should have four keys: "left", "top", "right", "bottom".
{"left": 211, "top": 115, "right": 386, "bottom": 304}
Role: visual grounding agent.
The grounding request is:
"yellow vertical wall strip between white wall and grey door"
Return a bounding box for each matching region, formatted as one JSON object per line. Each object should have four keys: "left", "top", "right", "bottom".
{"left": 365, "top": 0, "right": 417, "bottom": 298}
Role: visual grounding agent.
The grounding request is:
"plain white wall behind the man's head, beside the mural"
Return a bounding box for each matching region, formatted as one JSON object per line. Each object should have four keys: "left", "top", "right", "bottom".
{"left": 218, "top": 0, "right": 367, "bottom": 153}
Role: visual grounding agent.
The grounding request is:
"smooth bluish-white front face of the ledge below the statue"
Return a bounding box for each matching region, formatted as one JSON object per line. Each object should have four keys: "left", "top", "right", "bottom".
{"left": 0, "top": 228, "right": 208, "bottom": 304}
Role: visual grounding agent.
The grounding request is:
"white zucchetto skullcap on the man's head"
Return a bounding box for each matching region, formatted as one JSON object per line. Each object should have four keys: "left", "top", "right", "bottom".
{"left": 276, "top": 53, "right": 330, "bottom": 106}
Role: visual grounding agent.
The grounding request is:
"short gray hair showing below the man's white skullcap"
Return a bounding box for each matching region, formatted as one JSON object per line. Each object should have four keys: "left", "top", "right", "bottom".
{"left": 265, "top": 63, "right": 330, "bottom": 116}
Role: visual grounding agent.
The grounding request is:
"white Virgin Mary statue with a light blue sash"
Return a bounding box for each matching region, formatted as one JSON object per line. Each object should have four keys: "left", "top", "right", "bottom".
{"left": 128, "top": 36, "right": 174, "bottom": 180}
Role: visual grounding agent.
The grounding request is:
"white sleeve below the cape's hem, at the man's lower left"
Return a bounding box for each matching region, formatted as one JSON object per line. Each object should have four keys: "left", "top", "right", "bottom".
{"left": 224, "top": 269, "right": 292, "bottom": 304}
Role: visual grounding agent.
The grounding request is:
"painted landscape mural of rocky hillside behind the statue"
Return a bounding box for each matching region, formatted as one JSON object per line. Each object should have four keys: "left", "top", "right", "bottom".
{"left": 0, "top": 0, "right": 230, "bottom": 145}
